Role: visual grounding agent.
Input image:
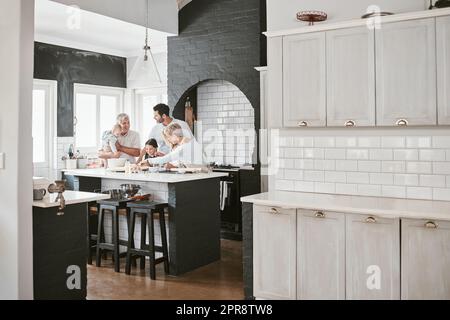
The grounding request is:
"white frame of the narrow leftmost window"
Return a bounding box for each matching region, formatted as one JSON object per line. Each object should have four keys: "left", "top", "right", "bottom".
{"left": 32, "top": 79, "right": 58, "bottom": 170}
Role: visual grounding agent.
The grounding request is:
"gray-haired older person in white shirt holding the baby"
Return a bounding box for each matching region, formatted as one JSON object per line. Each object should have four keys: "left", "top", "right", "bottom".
{"left": 99, "top": 113, "right": 141, "bottom": 163}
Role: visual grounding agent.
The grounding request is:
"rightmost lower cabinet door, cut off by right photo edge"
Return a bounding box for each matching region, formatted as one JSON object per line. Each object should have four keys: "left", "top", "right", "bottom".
{"left": 402, "top": 219, "right": 450, "bottom": 300}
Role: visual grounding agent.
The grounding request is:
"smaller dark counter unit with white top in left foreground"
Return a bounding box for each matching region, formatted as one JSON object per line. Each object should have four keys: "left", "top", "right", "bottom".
{"left": 33, "top": 191, "right": 109, "bottom": 300}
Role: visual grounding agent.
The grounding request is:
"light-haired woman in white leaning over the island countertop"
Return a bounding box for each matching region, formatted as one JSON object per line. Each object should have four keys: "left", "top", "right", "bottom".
{"left": 141, "top": 123, "right": 205, "bottom": 169}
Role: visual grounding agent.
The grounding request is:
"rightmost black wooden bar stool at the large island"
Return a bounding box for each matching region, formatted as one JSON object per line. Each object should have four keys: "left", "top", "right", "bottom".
{"left": 125, "top": 201, "right": 169, "bottom": 280}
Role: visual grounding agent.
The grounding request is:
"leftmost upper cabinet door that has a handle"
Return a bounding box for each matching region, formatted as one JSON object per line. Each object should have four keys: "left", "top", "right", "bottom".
{"left": 284, "top": 32, "right": 326, "bottom": 127}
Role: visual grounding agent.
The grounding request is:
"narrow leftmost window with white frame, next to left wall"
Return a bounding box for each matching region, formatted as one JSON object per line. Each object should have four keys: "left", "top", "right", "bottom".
{"left": 32, "top": 79, "right": 57, "bottom": 170}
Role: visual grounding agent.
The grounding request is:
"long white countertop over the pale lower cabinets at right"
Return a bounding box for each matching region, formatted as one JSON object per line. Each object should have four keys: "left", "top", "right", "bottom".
{"left": 242, "top": 191, "right": 450, "bottom": 220}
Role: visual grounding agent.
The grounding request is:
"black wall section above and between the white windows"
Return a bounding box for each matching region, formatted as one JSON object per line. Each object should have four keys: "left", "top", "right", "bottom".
{"left": 34, "top": 42, "right": 127, "bottom": 137}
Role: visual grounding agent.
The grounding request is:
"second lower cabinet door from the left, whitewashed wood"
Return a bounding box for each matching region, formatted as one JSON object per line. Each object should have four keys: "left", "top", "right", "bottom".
{"left": 297, "top": 210, "right": 345, "bottom": 300}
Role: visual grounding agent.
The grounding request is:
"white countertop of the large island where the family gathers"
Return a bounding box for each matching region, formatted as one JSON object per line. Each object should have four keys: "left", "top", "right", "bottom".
{"left": 63, "top": 169, "right": 228, "bottom": 183}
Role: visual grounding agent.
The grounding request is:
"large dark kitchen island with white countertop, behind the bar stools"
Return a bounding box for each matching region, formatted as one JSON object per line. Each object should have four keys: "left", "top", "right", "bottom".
{"left": 64, "top": 169, "right": 227, "bottom": 276}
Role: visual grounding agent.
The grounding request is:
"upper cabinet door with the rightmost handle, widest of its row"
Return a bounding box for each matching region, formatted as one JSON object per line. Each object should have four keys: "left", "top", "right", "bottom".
{"left": 375, "top": 18, "right": 437, "bottom": 126}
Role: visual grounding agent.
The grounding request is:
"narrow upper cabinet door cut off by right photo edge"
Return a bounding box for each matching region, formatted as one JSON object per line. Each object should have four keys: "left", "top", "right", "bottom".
{"left": 436, "top": 17, "right": 450, "bottom": 125}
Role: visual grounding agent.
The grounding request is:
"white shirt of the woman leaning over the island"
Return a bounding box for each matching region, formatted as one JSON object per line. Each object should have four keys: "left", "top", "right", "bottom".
{"left": 148, "top": 139, "right": 205, "bottom": 167}
